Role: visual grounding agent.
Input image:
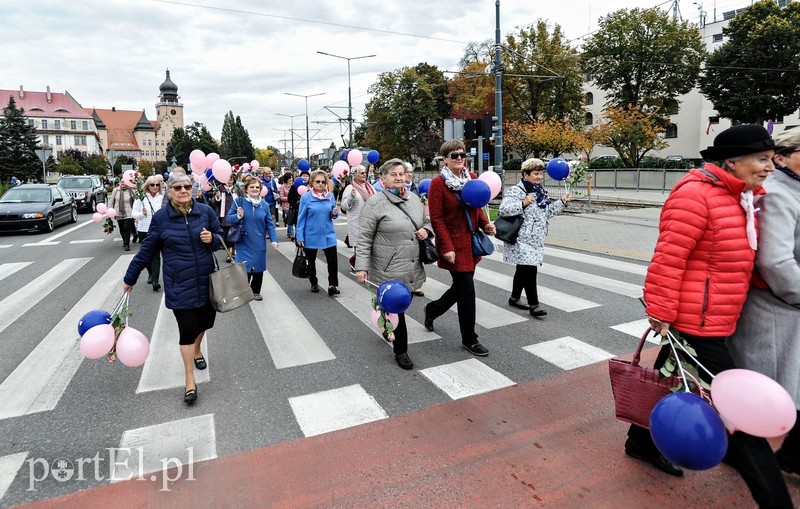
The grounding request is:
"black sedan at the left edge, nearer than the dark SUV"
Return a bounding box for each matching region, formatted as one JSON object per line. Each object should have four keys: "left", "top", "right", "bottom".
{"left": 0, "top": 184, "right": 78, "bottom": 232}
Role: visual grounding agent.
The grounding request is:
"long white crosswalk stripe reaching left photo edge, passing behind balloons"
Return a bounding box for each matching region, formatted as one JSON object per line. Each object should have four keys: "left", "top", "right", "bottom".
{"left": 0, "top": 255, "right": 133, "bottom": 419}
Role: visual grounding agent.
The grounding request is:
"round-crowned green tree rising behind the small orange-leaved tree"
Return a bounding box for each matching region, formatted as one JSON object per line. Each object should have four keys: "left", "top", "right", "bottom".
{"left": 582, "top": 8, "right": 706, "bottom": 125}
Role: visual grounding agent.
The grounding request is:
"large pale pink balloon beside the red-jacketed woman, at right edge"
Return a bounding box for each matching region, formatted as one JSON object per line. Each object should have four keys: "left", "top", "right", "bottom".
{"left": 711, "top": 369, "right": 797, "bottom": 438}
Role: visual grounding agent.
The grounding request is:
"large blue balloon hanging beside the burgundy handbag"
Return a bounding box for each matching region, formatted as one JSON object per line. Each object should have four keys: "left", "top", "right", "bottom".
{"left": 650, "top": 392, "right": 728, "bottom": 470}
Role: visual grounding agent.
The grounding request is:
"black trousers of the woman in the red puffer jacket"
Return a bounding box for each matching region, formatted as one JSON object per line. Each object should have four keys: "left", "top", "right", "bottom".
{"left": 628, "top": 333, "right": 794, "bottom": 508}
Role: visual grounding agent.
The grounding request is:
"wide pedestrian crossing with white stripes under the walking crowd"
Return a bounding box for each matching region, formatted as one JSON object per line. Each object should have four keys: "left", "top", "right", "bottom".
{"left": 0, "top": 227, "right": 647, "bottom": 505}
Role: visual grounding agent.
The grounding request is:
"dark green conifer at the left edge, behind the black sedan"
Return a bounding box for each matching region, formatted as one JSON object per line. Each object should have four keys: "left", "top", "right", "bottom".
{"left": 0, "top": 96, "right": 42, "bottom": 182}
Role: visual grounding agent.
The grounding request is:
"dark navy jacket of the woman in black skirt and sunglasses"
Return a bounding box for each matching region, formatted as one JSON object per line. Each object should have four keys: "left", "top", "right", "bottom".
{"left": 124, "top": 200, "right": 222, "bottom": 309}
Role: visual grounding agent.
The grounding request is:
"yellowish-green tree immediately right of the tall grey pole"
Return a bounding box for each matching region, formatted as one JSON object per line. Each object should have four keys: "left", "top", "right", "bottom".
{"left": 502, "top": 20, "right": 584, "bottom": 122}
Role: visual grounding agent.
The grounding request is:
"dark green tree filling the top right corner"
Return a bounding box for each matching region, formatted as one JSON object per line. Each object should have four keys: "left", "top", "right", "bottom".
{"left": 700, "top": 0, "right": 800, "bottom": 124}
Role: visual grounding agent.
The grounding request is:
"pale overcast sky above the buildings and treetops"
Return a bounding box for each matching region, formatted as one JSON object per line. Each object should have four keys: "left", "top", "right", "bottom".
{"left": 0, "top": 0, "right": 750, "bottom": 156}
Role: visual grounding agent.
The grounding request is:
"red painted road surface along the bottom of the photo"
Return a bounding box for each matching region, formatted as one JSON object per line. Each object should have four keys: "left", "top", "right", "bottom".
{"left": 21, "top": 348, "right": 800, "bottom": 509}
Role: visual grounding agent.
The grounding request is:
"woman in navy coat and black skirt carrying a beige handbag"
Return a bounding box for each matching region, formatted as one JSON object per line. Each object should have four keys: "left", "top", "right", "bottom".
{"left": 122, "top": 173, "right": 222, "bottom": 404}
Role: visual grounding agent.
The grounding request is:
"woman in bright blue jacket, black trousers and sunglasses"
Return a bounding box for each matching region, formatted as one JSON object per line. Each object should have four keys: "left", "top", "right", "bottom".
{"left": 297, "top": 170, "right": 339, "bottom": 297}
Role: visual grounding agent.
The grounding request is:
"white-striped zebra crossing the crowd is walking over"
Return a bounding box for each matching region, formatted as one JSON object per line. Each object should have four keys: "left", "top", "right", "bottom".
{"left": 0, "top": 232, "right": 647, "bottom": 503}
